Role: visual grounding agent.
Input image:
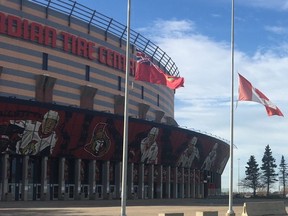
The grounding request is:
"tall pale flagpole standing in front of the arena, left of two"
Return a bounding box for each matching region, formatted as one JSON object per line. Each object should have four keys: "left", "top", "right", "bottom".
{"left": 121, "top": 0, "right": 131, "bottom": 216}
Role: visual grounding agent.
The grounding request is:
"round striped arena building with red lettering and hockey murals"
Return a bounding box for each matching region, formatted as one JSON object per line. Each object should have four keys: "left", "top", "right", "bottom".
{"left": 0, "top": 0, "right": 229, "bottom": 201}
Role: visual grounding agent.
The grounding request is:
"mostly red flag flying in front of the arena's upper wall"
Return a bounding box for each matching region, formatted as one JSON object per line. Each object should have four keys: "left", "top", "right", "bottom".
{"left": 135, "top": 52, "right": 184, "bottom": 89}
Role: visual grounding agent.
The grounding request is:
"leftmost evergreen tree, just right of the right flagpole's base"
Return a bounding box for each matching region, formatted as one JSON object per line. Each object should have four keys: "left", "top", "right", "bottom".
{"left": 242, "top": 155, "right": 261, "bottom": 197}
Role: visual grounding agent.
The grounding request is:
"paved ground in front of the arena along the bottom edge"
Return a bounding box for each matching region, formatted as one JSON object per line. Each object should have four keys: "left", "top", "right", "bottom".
{"left": 0, "top": 199, "right": 286, "bottom": 216}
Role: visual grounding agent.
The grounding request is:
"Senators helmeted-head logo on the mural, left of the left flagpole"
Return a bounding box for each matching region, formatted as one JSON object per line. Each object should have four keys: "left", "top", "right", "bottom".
{"left": 84, "top": 123, "right": 111, "bottom": 158}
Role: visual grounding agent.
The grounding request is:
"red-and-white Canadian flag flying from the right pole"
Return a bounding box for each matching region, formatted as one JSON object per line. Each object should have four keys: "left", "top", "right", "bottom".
{"left": 238, "top": 74, "right": 284, "bottom": 116}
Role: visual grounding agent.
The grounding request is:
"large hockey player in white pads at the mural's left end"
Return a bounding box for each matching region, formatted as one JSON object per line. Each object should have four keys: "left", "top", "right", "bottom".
{"left": 0, "top": 110, "right": 60, "bottom": 155}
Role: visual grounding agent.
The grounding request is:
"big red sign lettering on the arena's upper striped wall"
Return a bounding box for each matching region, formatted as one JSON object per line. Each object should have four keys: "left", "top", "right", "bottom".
{"left": 0, "top": 12, "right": 136, "bottom": 76}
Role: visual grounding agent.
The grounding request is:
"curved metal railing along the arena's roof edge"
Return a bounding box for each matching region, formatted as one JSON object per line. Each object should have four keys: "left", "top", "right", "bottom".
{"left": 27, "top": 0, "right": 180, "bottom": 76}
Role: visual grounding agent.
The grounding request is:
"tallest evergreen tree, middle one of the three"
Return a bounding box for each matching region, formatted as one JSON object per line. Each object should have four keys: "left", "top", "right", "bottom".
{"left": 261, "top": 145, "right": 277, "bottom": 196}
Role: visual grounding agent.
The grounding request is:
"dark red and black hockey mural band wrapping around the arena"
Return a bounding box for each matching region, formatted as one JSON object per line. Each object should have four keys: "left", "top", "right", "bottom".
{"left": 0, "top": 98, "right": 229, "bottom": 174}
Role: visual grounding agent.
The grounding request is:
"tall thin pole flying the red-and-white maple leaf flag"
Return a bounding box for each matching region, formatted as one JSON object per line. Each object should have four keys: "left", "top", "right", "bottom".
{"left": 226, "top": 0, "right": 235, "bottom": 216}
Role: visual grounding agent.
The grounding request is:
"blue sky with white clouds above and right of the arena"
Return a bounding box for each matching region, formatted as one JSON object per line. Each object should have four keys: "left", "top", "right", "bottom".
{"left": 77, "top": 0, "right": 288, "bottom": 192}
